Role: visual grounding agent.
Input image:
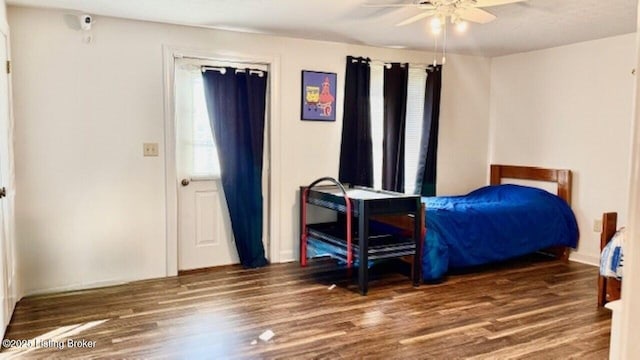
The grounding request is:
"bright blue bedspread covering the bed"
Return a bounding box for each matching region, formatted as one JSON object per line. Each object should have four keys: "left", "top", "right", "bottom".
{"left": 422, "top": 185, "right": 578, "bottom": 280}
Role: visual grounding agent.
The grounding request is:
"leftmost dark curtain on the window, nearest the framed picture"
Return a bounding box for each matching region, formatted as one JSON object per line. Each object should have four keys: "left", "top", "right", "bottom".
{"left": 338, "top": 56, "right": 373, "bottom": 186}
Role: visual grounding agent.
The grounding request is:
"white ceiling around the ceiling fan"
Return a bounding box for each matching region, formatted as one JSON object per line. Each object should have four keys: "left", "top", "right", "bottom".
{"left": 7, "top": 0, "right": 637, "bottom": 56}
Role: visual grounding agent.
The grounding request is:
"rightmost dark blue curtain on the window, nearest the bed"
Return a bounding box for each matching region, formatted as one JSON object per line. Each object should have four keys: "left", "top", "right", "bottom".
{"left": 416, "top": 65, "right": 442, "bottom": 196}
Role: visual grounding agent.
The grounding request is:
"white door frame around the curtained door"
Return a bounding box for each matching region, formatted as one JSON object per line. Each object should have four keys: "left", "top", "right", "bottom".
{"left": 162, "top": 45, "right": 281, "bottom": 276}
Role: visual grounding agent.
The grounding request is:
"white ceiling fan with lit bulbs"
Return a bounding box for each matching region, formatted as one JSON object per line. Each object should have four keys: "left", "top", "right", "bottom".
{"left": 364, "top": 0, "right": 526, "bottom": 27}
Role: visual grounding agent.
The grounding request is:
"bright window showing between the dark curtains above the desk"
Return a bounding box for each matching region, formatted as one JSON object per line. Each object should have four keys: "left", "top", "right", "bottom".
{"left": 370, "top": 63, "right": 427, "bottom": 194}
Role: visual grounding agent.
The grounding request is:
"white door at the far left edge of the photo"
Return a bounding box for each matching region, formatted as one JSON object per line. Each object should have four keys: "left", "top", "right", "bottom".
{"left": 0, "top": 33, "right": 17, "bottom": 337}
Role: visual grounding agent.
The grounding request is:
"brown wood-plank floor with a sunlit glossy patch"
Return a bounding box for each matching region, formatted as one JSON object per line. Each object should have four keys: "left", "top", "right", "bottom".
{"left": 0, "top": 258, "right": 611, "bottom": 359}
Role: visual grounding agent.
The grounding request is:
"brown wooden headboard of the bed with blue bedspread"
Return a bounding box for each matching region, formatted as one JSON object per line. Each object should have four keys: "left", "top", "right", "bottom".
{"left": 490, "top": 165, "right": 572, "bottom": 205}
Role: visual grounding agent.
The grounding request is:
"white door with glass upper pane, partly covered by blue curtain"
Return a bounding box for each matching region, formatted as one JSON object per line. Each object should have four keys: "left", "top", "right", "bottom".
{"left": 175, "top": 59, "right": 239, "bottom": 270}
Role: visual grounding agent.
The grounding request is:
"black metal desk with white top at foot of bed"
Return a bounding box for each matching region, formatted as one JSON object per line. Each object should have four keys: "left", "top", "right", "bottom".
{"left": 300, "top": 178, "right": 422, "bottom": 295}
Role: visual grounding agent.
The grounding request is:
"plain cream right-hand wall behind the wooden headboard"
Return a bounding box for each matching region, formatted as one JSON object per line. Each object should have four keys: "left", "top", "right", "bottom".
{"left": 489, "top": 34, "right": 636, "bottom": 263}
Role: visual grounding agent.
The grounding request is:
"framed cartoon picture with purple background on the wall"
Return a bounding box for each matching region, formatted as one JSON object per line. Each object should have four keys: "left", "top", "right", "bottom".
{"left": 301, "top": 70, "right": 337, "bottom": 121}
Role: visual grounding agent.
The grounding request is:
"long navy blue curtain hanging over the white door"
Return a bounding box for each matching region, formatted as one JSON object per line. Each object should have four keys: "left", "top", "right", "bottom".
{"left": 203, "top": 67, "right": 267, "bottom": 268}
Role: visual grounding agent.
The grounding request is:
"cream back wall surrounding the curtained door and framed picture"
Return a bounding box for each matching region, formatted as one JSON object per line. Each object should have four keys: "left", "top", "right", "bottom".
{"left": 9, "top": 7, "right": 491, "bottom": 293}
